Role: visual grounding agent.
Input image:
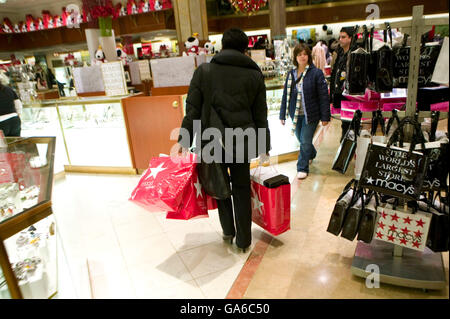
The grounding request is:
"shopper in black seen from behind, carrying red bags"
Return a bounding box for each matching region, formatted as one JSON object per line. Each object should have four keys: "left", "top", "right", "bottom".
{"left": 178, "top": 28, "right": 270, "bottom": 251}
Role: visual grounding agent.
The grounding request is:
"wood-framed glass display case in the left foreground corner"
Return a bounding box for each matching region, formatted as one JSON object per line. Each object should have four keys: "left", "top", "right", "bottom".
{"left": 0, "top": 137, "right": 58, "bottom": 299}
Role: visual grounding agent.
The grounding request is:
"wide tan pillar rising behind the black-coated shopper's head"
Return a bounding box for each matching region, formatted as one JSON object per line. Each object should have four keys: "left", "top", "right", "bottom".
{"left": 172, "top": 0, "right": 208, "bottom": 53}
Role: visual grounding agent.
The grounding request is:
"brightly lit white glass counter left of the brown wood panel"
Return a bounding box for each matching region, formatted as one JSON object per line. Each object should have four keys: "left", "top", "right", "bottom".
{"left": 22, "top": 95, "right": 137, "bottom": 173}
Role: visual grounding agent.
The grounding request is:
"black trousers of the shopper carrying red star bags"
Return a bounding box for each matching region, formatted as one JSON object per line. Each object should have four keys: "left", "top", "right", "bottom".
{"left": 217, "top": 163, "right": 252, "bottom": 248}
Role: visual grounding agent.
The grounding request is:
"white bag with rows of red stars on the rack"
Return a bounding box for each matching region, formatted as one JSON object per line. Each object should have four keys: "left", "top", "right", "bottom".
{"left": 374, "top": 207, "right": 432, "bottom": 251}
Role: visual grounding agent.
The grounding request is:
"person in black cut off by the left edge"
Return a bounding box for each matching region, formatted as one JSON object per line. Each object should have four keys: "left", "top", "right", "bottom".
{"left": 0, "top": 77, "right": 22, "bottom": 136}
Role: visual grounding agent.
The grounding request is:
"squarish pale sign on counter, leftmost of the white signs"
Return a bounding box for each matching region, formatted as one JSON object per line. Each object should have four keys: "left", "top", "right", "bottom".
{"left": 72, "top": 65, "right": 105, "bottom": 93}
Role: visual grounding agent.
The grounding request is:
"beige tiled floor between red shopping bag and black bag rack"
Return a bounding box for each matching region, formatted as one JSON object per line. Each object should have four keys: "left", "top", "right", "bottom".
{"left": 241, "top": 120, "right": 449, "bottom": 299}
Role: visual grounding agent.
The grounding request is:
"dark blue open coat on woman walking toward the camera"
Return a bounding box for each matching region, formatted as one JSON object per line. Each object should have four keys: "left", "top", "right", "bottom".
{"left": 280, "top": 64, "right": 331, "bottom": 123}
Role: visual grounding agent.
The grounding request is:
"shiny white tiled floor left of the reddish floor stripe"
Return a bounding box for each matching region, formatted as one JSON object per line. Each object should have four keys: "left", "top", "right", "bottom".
{"left": 53, "top": 159, "right": 295, "bottom": 298}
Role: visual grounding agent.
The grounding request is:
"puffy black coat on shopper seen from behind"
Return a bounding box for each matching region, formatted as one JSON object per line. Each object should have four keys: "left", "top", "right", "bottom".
{"left": 178, "top": 49, "right": 270, "bottom": 160}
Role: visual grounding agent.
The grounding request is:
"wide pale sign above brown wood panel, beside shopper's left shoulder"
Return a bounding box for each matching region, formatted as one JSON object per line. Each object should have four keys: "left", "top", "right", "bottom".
{"left": 150, "top": 56, "right": 195, "bottom": 88}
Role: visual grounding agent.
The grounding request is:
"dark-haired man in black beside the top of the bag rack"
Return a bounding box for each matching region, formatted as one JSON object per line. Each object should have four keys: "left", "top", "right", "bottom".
{"left": 330, "top": 27, "right": 353, "bottom": 140}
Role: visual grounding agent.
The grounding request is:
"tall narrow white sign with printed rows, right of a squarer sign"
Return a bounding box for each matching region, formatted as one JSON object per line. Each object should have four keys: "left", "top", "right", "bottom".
{"left": 101, "top": 61, "right": 128, "bottom": 96}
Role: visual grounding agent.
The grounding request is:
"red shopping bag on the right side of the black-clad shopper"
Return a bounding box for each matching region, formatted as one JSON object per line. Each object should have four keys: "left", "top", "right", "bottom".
{"left": 251, "top": 180, "right": 291, "bottom": 236}
